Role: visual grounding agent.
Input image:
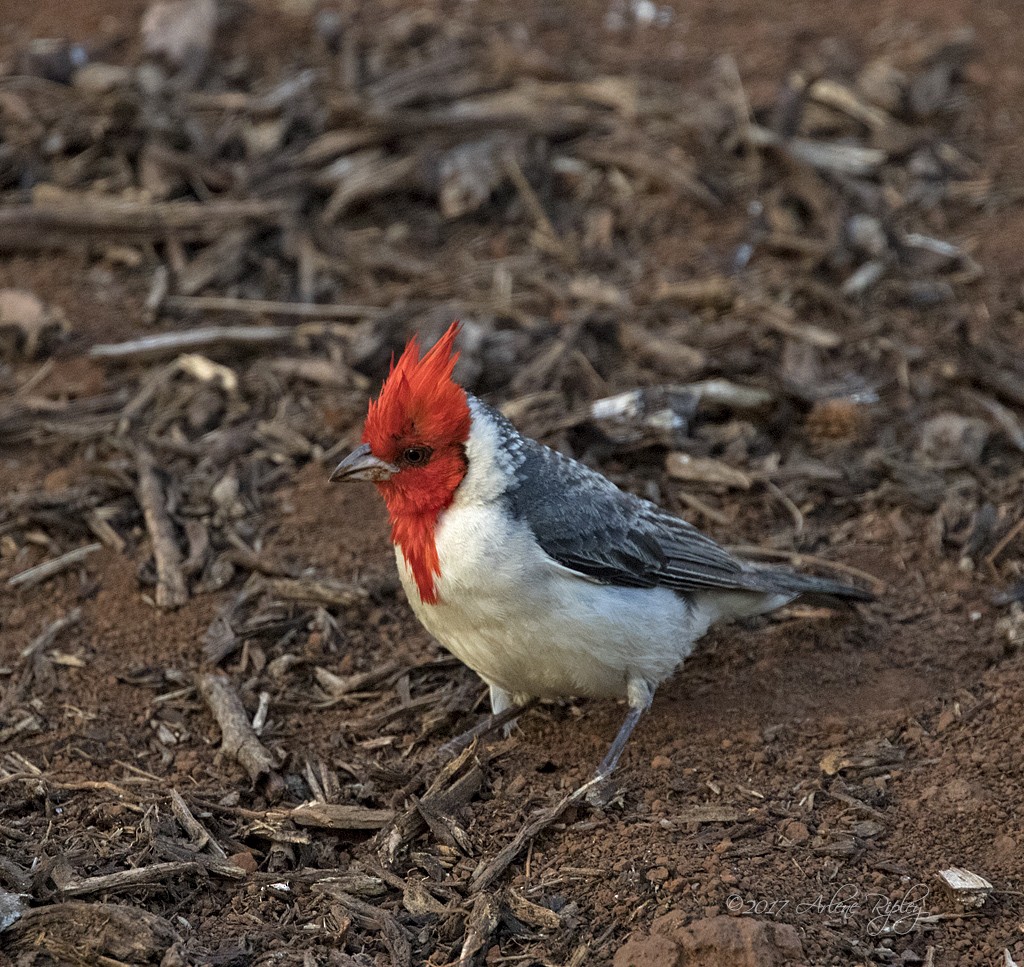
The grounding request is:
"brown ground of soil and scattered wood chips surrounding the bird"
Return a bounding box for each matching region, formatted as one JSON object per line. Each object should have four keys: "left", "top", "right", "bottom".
{"left": 0, "top": 0, "right": 1024, "bottom": 967}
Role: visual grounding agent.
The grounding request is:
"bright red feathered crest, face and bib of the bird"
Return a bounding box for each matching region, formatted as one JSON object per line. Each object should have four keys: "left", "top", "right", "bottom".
{"left": 362, "top": 322, "right": 470, "bottom": 604}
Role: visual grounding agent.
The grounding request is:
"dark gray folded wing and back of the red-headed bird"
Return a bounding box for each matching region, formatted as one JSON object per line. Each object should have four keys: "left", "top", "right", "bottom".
{"left": 479, "top": 399, "right": 764, "bottom": 591}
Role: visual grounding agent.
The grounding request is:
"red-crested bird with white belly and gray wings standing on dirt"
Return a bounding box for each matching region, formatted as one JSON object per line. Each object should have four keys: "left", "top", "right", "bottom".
{"left": 330, "top": 322, "right": 873, "bottom": 782}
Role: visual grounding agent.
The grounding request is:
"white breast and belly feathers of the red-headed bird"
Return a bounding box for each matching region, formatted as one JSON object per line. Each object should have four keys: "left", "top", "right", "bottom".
{"left": 396, "top": 505, "right": 718, "bottom": 698}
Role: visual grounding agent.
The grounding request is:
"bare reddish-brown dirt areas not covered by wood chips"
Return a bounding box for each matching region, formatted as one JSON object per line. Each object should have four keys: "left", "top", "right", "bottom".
{"left": 0, "top": 0, "right": 1024, "bottom": 967}
